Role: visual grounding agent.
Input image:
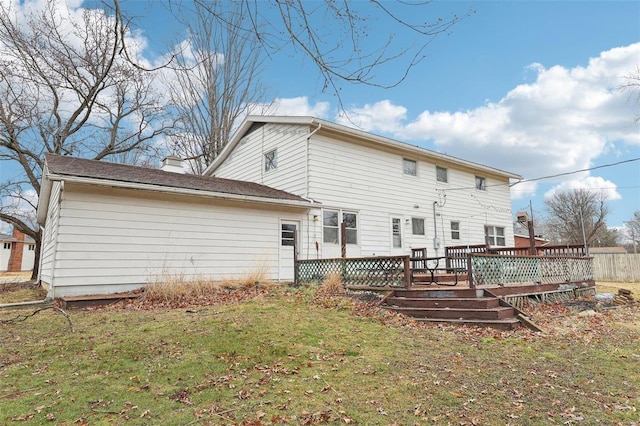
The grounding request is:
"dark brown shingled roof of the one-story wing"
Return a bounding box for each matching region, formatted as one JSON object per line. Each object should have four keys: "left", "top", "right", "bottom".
{"left": 45, "top": 154, "right": 308, "bottom": 201}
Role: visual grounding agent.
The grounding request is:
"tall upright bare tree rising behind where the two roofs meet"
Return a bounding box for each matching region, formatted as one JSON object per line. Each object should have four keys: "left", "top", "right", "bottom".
{"left": 164, "top": 1, "right": 264, "bottom": 174}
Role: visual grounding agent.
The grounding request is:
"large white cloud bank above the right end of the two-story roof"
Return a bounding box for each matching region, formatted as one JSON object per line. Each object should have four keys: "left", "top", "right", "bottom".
{"left": 338, "top": 43, "right": 640, "bottom": 200}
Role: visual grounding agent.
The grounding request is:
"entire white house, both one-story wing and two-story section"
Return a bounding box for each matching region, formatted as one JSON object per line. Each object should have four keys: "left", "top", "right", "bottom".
{"left": 37, "top": 117, "right": 520, "bottom": 297}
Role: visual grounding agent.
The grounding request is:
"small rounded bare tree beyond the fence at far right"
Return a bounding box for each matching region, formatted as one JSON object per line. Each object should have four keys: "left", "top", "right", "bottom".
{"left": 545, "top": 189, "right": 609, "bottom": 245}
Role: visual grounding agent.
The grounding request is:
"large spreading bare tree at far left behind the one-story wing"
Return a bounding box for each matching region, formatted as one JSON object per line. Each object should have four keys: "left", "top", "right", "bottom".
{"left": 0, "top": 0, "right": 171, "bottom": 278}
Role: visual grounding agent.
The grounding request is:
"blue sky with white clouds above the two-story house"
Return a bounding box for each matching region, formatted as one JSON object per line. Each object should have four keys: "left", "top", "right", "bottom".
{"left": 1, "top": 0, "right": 640, "bottom": 233}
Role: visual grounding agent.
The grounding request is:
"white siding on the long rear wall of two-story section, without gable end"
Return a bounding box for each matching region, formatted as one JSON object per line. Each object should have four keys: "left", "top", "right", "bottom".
{"left": 309, "top": 135, "right": 513, "bottom": 256}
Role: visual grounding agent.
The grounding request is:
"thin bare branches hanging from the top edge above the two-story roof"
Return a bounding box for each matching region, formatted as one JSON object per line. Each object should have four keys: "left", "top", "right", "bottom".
{"left": 188, "top": 0, "right": 474, "bottom": 104}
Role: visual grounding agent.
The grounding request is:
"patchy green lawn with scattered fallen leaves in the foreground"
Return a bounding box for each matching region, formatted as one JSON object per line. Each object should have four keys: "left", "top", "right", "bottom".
{"left": 0, "top": 282, "right": 640, "bottom": 425}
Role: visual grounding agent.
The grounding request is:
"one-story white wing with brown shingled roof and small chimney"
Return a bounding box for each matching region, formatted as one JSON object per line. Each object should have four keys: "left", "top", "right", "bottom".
{"left": 37, "top": 155, "right": 315, "bottom": 297}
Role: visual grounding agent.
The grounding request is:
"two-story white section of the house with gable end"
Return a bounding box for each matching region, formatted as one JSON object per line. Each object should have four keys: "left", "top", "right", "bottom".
{"left": 204, "top": 116, "right": 520, "bottom": 258}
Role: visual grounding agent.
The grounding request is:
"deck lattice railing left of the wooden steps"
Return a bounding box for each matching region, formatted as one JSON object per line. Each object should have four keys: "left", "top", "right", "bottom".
{"left": 295, "top": 256, "right": 411, "bottom": 288}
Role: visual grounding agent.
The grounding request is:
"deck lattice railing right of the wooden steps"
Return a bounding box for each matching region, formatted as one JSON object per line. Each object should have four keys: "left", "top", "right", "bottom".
{"left": 469, "top": 254, "right": 593, "bottom": 287}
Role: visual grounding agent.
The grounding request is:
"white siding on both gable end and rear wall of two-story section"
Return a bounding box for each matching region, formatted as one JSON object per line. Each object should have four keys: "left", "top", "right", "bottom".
{"left": 215, "top": 123, "right": 513, "bottom": 258}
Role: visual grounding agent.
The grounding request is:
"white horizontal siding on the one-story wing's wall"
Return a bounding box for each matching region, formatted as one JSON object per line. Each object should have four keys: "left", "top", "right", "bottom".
{"left": 43, "top": 183, "right": 303, "bottom": 296}
